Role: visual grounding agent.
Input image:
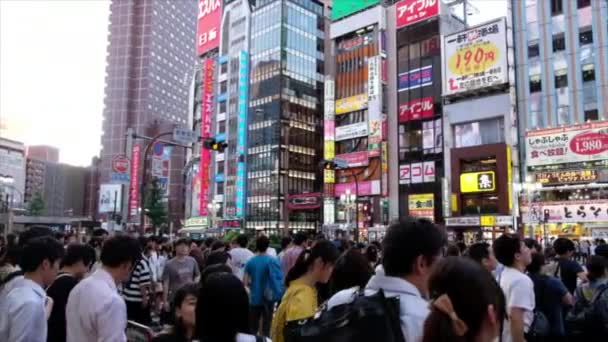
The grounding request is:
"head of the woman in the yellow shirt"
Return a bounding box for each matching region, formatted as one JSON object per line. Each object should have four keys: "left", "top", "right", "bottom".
{"left": 285, "top": 240, "right": 338, "bottom": 286}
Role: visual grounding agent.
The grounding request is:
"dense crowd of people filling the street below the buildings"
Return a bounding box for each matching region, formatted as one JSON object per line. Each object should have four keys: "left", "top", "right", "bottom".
{"left": 0, "top": 219, "right": 608, "bottom": 342}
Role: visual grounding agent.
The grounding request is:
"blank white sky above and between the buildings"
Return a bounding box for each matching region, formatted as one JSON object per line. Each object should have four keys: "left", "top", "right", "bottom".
{"left": 0, "top": 0, "right": 507, "bottom": 166}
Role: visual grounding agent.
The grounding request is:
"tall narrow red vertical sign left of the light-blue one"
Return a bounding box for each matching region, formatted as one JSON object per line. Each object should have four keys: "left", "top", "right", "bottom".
{"left": 199, "top": 58, "right": 215, "bottom": 216}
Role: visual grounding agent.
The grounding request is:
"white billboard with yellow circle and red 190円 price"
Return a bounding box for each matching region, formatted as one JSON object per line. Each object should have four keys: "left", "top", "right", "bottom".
{"left": 443, "top": 19, "right": 509, "bottom": 95}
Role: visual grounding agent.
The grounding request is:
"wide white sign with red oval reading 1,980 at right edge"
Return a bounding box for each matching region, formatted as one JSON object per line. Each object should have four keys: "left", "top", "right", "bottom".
{"left": 526, "top": 121, "right": 608, "bottom": 166}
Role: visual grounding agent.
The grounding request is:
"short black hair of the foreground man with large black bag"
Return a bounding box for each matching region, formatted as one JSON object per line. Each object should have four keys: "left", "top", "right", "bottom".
{"left": 382, "top": 217, "right": 446, "bottom": 277}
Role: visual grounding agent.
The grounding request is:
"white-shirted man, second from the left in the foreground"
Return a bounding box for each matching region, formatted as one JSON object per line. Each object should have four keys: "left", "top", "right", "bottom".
{"left": 66, "top": 236, "right": 141, "bottom": 342}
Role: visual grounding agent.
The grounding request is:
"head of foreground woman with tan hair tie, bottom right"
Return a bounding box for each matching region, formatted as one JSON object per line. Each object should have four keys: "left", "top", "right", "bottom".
{"left": 423, "top": 257, "right": 506, "bottom": 342}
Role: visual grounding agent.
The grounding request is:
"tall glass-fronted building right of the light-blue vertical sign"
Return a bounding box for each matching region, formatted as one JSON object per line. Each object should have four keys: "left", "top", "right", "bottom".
{"left": 246, "top": 0, "right": 324, "bottom": 231}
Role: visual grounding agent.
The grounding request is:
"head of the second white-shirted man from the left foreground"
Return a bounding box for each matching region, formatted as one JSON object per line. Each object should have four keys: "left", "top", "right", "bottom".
{"left": 100, "top": 235, "right": 141, "bottom": 283}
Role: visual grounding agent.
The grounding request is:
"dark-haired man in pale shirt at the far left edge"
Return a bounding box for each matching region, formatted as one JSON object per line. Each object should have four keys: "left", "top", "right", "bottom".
{"left": 0, "top": 236, "right": 64, "bottom": 342}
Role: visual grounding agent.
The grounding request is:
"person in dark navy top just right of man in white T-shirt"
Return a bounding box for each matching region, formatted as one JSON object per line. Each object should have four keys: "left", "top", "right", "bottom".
{"left": 527, "top": 252, "right": 574, "bottom": 342}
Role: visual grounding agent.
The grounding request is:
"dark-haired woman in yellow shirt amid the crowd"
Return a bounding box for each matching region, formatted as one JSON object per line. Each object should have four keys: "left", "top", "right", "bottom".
{"left": 271, "top": 240, "right": 338, "bottom": 342}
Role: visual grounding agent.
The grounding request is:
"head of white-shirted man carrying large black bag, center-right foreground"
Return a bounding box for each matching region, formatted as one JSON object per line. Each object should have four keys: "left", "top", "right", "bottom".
{"left": 382, "top": 218, "right": 446, "bottom": 293}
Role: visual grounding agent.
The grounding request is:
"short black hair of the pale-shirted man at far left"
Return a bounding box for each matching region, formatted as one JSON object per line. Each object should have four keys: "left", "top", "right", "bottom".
{"left": 19, "top": 236, "right": 64, "bottom": 272}
